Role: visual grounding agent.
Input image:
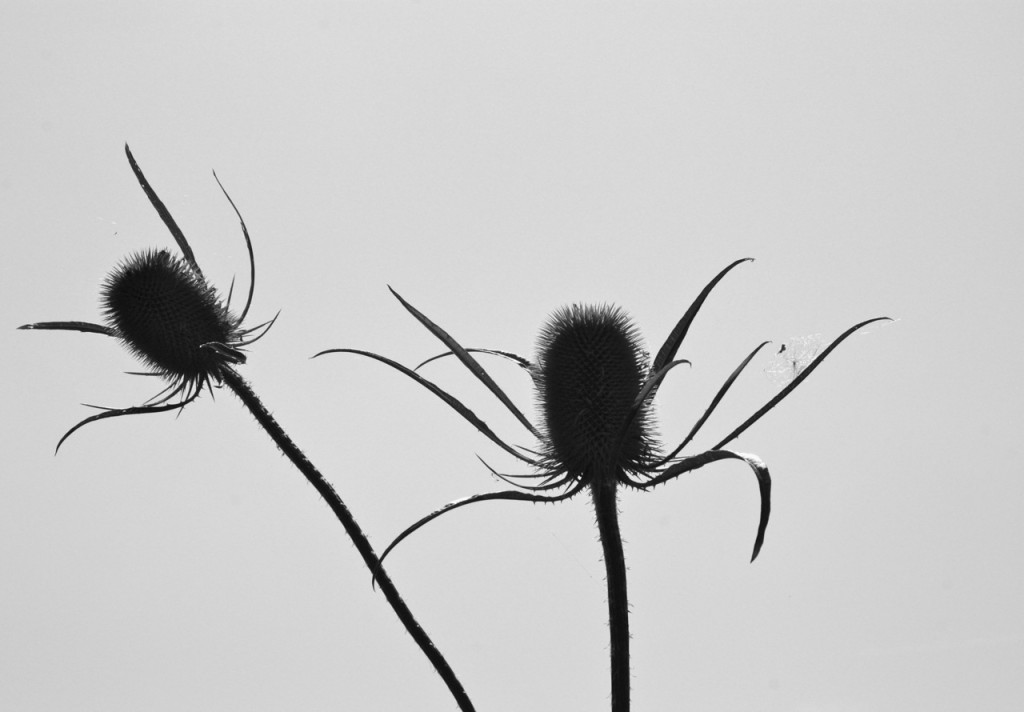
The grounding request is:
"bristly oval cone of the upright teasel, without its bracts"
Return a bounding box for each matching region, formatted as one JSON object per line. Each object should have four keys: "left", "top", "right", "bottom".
{"left": 536, "top": 304, "right": 652, "bottom": 477}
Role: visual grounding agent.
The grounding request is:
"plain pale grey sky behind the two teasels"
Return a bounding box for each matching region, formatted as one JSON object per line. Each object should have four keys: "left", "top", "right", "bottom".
{"left": 0, "top": 2, "right": 1024, "bottom": 712}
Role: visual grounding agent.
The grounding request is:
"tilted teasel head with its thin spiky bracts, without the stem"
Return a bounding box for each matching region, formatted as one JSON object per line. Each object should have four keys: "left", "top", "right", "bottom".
{"left": 20, "top": 145, "right": 276, "bottom": 449}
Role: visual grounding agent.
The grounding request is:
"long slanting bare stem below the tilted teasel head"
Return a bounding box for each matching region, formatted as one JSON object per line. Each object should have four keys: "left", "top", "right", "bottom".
{"left": 222, "top": 369, "right": 474, "bottom": 712}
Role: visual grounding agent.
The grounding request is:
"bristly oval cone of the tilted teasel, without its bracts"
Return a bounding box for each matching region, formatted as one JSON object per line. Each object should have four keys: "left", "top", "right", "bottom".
{"left": 100, "top": 250, "right": 245, "bottom": 387}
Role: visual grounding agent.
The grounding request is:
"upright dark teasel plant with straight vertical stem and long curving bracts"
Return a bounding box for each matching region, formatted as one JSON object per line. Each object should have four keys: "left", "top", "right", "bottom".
{"left": 316, "top": 259, "right": 888, "bottom": 712}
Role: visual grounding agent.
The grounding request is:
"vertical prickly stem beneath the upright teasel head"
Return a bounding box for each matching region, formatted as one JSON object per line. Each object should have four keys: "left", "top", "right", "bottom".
{"left": 590, "top": 473, "right": 630, "bottom": 712}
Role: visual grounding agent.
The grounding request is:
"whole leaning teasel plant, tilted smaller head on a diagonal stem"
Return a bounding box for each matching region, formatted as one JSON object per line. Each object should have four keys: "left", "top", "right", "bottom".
{"left": 19, "top": 145, "right": 474, "bottom": 712}
